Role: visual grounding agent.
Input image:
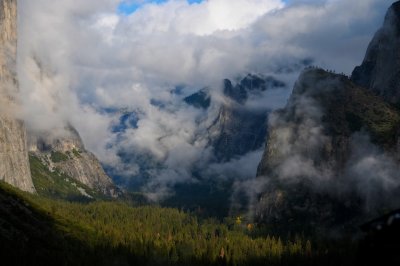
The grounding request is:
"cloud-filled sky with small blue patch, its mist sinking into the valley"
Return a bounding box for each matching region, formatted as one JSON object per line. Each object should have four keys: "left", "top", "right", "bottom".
{"left": 18, "top": 0, "right": 392, "bottom": 198}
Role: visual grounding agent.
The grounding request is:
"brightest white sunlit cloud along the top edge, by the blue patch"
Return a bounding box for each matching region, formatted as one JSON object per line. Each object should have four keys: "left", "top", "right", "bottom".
{"left": 115, "top": 0, "right": 284, "bottom": 36}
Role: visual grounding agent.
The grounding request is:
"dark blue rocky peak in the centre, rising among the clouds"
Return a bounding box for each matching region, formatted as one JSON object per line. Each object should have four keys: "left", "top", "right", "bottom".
{"left": 208, "top": 74, "right": 286, "bottom": 161}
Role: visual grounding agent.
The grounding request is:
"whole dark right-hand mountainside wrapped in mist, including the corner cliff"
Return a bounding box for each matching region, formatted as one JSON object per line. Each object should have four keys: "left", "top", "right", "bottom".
{"left": 256, "top": 2, "right": 400, "bottom": 233}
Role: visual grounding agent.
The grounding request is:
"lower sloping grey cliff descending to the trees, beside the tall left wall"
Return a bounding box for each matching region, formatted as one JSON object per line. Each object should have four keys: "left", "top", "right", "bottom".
{"left": 29, "top": 127, "right": 121, "bottom": 197}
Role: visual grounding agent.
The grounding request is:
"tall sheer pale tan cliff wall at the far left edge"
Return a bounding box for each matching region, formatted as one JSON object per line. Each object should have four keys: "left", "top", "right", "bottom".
{"left": 0, "top": 0, "right": 35, "bottom": 192}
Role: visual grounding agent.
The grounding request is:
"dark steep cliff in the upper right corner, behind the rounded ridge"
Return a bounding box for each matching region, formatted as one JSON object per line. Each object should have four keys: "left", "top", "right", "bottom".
{"left": 352, "top": 1, "right": 400, "bottom": 105}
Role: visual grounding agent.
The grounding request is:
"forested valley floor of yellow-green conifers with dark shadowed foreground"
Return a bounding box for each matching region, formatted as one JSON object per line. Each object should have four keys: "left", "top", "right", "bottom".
{"left": 0, "top": 183, "right": 360, "bottom": 265}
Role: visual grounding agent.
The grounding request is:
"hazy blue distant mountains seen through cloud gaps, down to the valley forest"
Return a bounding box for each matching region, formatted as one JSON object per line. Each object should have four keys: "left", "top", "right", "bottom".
{"left": 106, "top": 74, "right": 287, "bottom": 216}
